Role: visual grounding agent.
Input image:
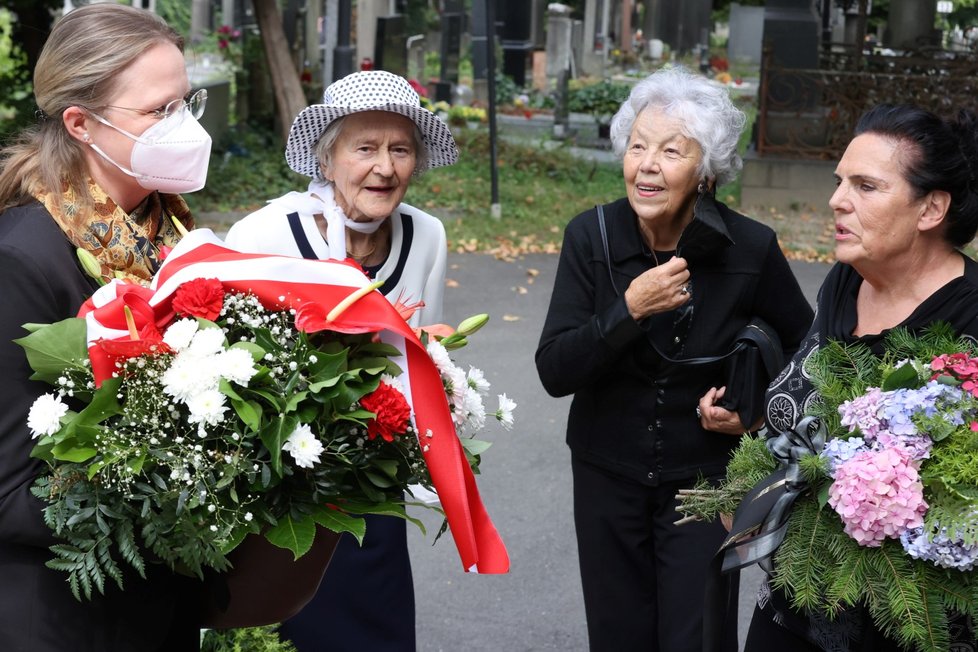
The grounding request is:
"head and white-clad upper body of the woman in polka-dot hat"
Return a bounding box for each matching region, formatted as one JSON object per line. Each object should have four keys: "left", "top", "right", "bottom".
{"left": 227, "top": 70, "right": 458, "bottom": 326}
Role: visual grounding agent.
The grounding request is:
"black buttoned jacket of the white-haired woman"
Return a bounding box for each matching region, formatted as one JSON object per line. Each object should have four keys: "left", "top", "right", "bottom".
{"left": 536, "top": 199, "right": 813, "bottom": 485}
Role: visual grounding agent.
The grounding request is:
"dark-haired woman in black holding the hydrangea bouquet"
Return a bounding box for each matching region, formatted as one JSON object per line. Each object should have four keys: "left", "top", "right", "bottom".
{"left": 746, "top": 105, "right": 978, "bottom": 652}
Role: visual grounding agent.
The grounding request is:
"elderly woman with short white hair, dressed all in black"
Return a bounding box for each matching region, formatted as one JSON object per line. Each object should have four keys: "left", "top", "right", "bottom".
{"left": 536, "top": 68, "right": 813, "bottom": 652}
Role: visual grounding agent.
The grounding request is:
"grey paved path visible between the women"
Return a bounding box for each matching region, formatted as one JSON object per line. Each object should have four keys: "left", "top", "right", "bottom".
{"left": 400, "top": 254, "right": 828, "bottom": 652}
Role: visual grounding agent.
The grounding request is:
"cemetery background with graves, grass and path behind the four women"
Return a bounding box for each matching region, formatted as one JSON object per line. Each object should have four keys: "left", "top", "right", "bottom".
{"left": 0, "top": 0, "right": 978, "bottom": 650}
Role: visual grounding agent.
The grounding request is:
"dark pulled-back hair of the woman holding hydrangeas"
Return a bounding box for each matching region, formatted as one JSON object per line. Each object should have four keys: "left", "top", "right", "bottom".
{"left": 855, "top": 104, "right": 978, "bottom": 248}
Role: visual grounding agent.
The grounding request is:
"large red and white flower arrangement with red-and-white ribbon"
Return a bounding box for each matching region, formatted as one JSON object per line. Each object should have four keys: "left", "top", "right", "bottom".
{"left": 19, "top": 232, "right": 515, "bottom": 597}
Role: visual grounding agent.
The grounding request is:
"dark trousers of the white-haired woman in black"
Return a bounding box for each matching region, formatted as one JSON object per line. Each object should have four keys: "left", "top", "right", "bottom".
{"left": 571, "top": 457, "right": 737, "bottom": 652}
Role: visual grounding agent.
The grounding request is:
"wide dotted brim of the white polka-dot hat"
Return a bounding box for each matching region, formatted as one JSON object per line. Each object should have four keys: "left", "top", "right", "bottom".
{"left": 285, "top": 104, "right": 458, "bottom": 179}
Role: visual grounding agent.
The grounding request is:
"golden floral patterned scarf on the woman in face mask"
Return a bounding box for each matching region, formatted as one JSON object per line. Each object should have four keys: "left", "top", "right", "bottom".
{"left": 34, "top": 180, "right": 194, "bottom": 285}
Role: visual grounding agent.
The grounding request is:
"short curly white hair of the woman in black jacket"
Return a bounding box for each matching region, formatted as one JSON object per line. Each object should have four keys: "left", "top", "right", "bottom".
{"left": 611, "top": 67, "right": 747, "bottom": 186}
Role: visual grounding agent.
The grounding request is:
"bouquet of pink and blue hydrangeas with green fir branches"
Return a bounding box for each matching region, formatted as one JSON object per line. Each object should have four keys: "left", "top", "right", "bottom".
{"left": 681, "top": 325, "right": 978, "bottom": 651}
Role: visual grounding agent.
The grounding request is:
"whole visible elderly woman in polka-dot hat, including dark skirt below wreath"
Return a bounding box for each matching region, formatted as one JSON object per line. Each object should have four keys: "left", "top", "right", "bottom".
{"left": 227, "top": 70, "right": 458, "bottom": 652}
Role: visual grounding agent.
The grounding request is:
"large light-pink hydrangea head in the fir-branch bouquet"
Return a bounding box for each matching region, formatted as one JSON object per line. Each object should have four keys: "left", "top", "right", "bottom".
{"left": 829, "top": 447, "right": 927, "bottom": 547}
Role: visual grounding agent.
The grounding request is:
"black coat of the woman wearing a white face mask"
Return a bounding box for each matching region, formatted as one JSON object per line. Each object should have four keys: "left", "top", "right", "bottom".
{"left": 0, "top": 202, "right": 200, "bottom": 652}
